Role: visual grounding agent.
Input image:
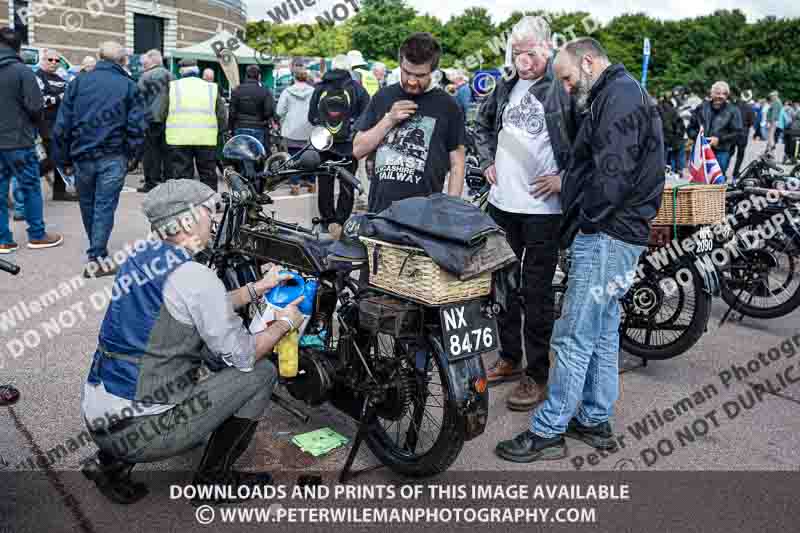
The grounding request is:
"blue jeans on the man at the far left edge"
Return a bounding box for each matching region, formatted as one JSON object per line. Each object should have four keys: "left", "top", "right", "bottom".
{"left": 0, "top": 148, "right": 45, "bottom": 244}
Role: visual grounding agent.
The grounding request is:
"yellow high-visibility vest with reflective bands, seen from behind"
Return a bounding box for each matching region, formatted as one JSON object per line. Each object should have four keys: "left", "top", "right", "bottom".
{"left": 167, "top": 77, "right": 217, "bottom": 146}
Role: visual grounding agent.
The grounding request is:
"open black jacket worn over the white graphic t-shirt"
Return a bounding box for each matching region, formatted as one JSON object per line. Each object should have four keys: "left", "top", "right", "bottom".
{"left": 475, "top": 61, "right": 578, "bottom": 171}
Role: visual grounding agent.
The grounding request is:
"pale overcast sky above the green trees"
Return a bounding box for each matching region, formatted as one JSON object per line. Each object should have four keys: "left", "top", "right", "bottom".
{"left": 246, "top": 0, "right": 800, "bottom": 23}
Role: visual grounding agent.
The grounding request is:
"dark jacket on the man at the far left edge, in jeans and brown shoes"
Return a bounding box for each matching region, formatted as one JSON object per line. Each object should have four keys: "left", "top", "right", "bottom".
{"left": 0, "top": 45, "right": 44, "bottom": 150}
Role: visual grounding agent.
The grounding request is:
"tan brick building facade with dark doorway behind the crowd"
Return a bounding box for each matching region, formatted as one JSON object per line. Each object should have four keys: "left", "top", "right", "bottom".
{"left": 0, "top": 0, "right": 247, "bottom": 64}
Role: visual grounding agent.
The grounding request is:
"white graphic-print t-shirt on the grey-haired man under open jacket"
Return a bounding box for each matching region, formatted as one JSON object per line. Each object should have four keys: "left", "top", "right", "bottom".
{"left": 489, "top": 80, "right": 561, "bottom": 215}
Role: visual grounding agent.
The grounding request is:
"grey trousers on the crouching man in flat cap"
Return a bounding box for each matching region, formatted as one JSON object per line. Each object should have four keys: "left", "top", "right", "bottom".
{"left": 92, "top": 359, "right": 278, "bottom": 463}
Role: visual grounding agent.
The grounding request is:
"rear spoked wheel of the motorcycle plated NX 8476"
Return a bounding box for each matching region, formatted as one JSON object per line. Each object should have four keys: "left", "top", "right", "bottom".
{"left": 365, "top": 334, "right": 464, "bottom": 478}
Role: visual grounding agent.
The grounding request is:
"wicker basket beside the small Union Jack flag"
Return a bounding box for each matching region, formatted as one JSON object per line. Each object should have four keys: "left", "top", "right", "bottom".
{"left": 653, "top": 185, "right": 726, "bottom": 226}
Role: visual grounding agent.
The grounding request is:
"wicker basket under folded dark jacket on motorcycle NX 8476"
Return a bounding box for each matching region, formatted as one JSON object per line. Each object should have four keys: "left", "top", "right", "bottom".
{"left": 360, "top": 237, "right": 492, "bottom": 305}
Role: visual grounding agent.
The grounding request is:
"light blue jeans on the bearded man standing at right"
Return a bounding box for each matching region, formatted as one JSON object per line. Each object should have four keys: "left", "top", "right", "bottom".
{"left": 531, "top": 232, "right": 645, "bottom": 438}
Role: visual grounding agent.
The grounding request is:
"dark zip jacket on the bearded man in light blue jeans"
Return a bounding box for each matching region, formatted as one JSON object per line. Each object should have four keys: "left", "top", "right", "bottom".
{"left": 561, "top": 64, "right": 665, "bottom": 248}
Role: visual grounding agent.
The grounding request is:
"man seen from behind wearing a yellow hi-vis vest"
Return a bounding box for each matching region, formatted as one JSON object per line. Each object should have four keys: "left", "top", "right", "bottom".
{"left": 162, "top": 59, "right": 225, "bottom": 190}
